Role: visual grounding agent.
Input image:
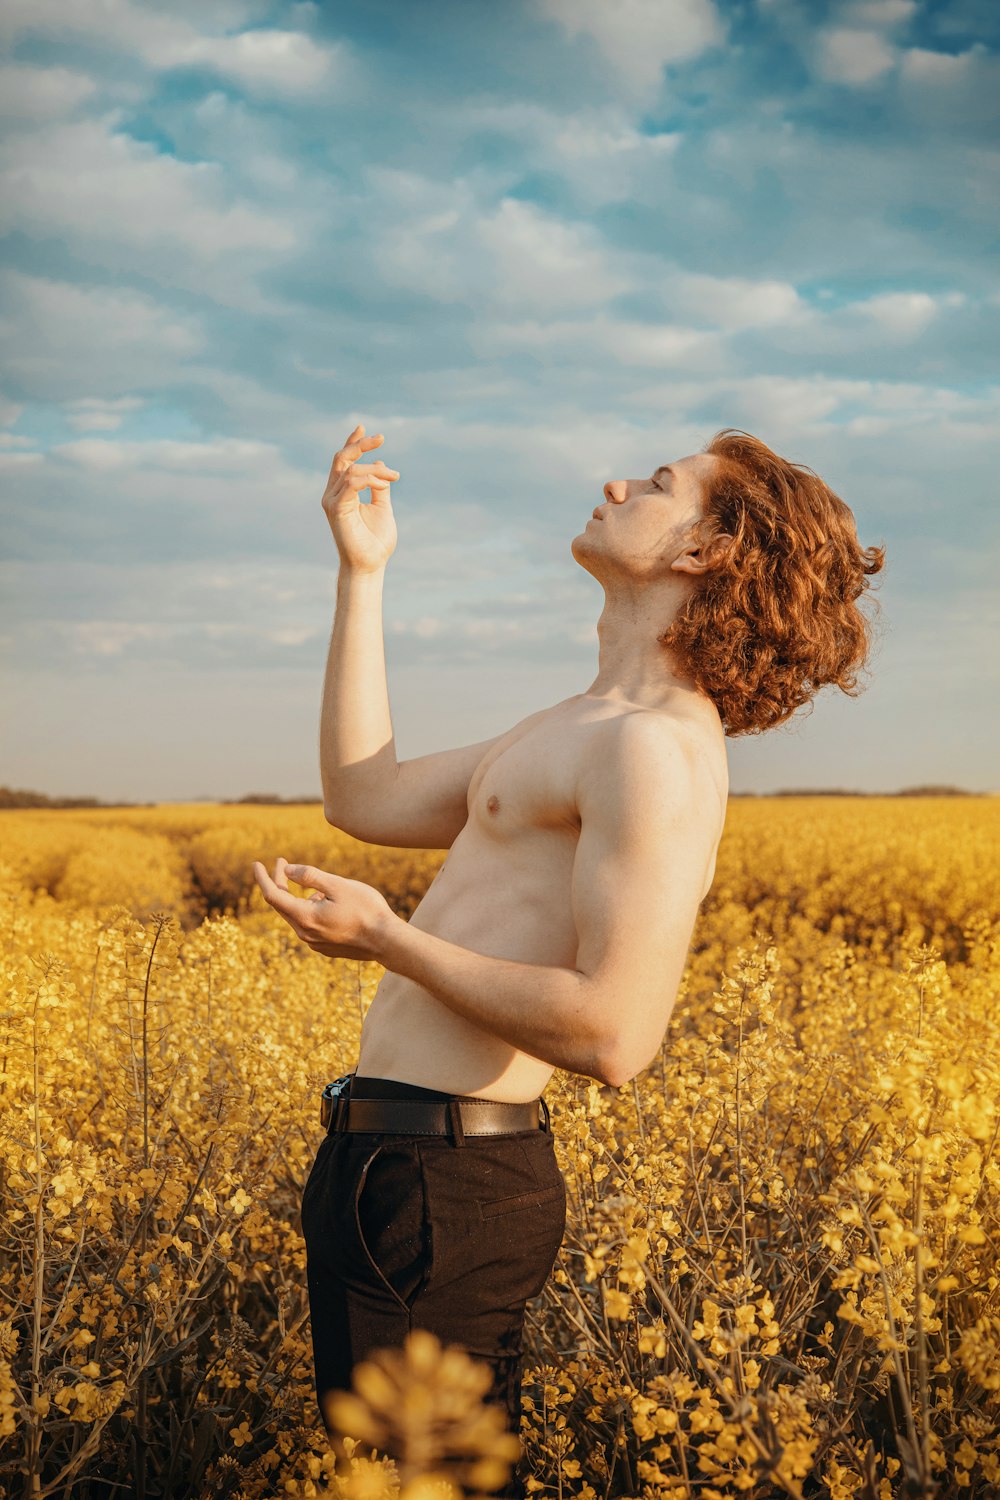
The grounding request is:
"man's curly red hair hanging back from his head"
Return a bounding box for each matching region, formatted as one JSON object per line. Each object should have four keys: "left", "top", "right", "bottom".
{"left": 660, "top": 428, "right": 885, "bottom": 738}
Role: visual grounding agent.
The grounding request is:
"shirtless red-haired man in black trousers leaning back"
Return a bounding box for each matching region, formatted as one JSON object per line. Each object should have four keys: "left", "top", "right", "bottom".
{"left": 253, "top": 426, "right": 882, "bottom": 1494}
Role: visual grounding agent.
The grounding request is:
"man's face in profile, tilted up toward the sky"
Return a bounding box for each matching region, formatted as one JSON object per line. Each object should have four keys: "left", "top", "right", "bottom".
{"left": 573, "top": 453, "right": 720, "bottom": 581}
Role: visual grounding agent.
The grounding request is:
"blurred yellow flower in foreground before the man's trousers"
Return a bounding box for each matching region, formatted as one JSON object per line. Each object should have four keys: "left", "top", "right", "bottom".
{"left": 327, "top": 1329, "right": 520, "bottom": 1500}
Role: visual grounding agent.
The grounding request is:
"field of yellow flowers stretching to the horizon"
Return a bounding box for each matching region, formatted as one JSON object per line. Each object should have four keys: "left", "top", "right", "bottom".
{"left": 0, "top": 797, "right": 1000, "bottom": 1500}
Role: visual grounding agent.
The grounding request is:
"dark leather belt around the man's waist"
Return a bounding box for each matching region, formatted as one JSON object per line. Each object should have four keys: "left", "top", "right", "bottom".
{"left": 319, "top": 1074, "right": 550, "bottom": 1145}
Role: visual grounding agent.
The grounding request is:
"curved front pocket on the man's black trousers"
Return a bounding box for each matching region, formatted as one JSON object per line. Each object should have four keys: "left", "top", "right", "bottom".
{"left": 354, "top": 1142, "right": 430, "bottom": 1311}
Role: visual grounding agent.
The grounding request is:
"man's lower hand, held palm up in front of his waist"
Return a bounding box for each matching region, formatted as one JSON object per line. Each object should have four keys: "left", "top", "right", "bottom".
{"left": 253, "top": 855, "right": 400, "bottom": 963}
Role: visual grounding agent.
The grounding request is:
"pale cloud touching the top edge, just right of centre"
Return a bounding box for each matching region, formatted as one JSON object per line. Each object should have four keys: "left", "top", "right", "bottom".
{"left": 540, "top": 0, "right": 726, "bottom": 90}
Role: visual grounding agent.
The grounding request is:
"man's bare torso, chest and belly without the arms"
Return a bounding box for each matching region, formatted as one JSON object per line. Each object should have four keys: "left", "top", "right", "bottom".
{"left": 357, "top": 695, "right": 729, "bottom": 1101}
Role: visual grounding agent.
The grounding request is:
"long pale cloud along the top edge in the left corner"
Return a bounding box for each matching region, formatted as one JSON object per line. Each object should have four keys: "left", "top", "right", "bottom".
{"left": 0, "top": 0, "right": 339, "bottom": 98}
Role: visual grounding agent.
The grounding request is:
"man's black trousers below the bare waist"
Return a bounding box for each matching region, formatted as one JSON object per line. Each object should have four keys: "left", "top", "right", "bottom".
{"left": 301, "top": 1077, "right": 567, "bottom": 1496}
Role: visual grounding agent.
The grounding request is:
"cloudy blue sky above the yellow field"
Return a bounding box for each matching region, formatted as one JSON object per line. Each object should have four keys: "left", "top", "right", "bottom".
{"left": 0, "top": 0, "right": 1000, "bottom": 801}
